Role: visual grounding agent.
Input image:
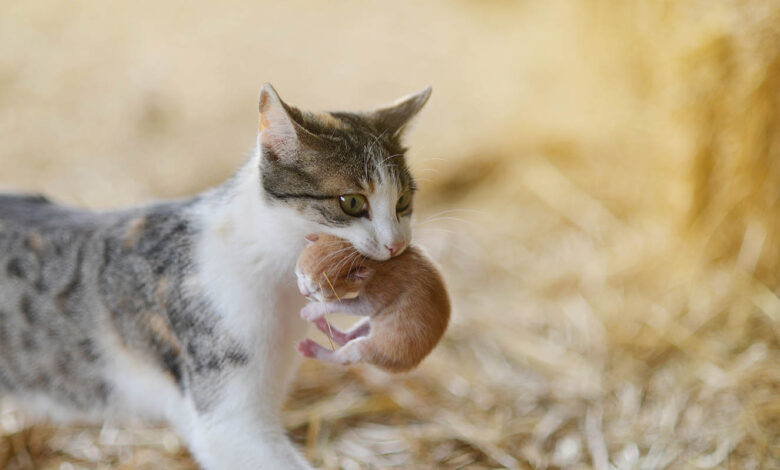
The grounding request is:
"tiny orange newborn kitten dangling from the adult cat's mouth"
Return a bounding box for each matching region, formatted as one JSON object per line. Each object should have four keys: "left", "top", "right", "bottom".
{"left": 295, "top": 234, "right": 450, "bottom": 372}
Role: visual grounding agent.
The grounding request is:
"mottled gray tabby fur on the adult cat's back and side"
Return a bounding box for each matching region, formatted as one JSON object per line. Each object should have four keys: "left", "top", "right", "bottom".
{"left": 0, "top": 195, "right": 249, "bottom": 411}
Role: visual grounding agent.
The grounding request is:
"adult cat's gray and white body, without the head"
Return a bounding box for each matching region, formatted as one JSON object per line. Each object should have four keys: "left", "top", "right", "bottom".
{"left": 0, "top": 181, "right": 306, "bottom": 468}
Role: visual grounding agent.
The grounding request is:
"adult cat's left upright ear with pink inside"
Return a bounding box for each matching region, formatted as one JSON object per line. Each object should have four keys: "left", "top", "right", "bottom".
{"left": 257, "top": 83, "right": 317, "bottom": 160}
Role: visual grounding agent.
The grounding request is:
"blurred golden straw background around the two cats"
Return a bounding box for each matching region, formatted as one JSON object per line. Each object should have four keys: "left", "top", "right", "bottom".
{"left": 0, "top": 0, "right": 780, "bottom": 470}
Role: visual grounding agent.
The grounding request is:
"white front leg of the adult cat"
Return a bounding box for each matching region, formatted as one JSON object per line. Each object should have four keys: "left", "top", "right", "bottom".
{"left": 183, "top": 288, "right": 311, "bottom": 470}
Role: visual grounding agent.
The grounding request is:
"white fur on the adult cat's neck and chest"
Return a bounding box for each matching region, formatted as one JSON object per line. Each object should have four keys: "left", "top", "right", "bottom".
{"left": 193, "top": 160, "right": 315, "bottom": 404}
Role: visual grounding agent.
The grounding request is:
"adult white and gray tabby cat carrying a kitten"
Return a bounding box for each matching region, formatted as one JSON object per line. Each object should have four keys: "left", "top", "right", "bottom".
{"left": 0, "top": 85, "right": 430, "bottom": 470}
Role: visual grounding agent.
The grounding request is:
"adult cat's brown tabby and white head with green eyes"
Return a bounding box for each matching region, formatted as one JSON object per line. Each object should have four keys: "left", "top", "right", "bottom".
{"left": 257, "top": 84, "right": 431, "bottom": 260}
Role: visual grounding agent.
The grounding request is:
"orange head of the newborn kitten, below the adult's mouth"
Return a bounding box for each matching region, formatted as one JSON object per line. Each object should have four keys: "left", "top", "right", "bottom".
{"left": 295, "top": 234, "right": 374, "bottom": 302}
